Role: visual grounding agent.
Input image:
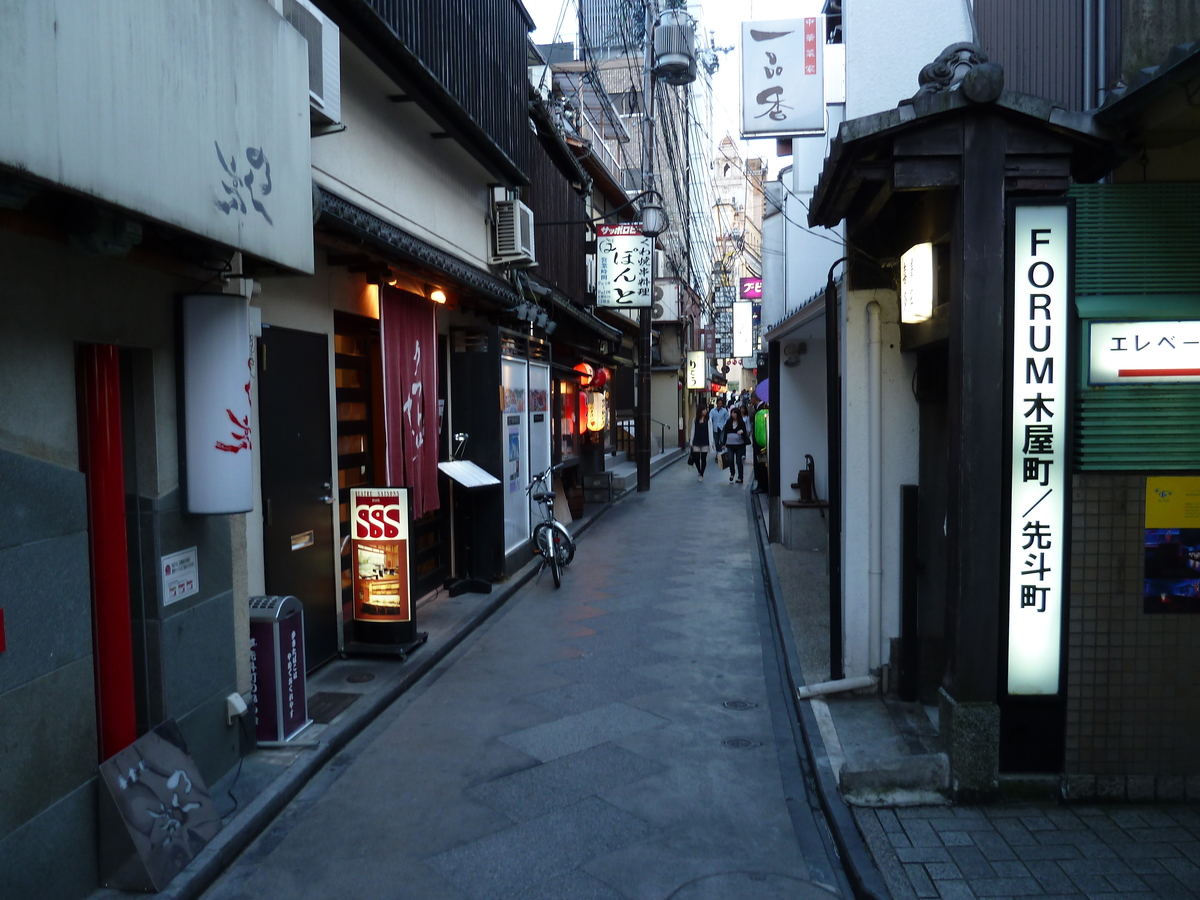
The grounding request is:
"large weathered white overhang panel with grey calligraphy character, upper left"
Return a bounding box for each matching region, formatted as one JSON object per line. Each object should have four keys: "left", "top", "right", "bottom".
{"left": 0, "top": 0, "right": 312, "bottom": 271}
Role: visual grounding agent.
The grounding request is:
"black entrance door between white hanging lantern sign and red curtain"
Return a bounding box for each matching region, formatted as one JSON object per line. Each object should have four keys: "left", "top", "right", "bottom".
{"left": 258, "top": 326, "right": 337, "bottom": 670}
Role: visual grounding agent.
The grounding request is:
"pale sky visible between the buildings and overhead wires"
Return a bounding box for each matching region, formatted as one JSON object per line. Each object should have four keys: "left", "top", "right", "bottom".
{"left": 523, "top": 0, "right": 822, "bottom": 178}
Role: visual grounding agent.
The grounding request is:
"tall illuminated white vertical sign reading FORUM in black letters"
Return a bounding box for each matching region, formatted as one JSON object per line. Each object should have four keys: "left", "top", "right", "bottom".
{"left": 1008, "top": 205, "right": 1070, "bottom": 696}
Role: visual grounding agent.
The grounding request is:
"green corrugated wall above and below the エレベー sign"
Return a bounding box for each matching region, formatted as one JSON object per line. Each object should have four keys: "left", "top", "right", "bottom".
{"left": 1069, "top": 184, "right": 1200, "bottom": 472}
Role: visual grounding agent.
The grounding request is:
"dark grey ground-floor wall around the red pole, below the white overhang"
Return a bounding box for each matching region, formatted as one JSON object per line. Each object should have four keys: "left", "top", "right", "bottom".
{"left": 0, "top": 233, "right": 238, "bottom": 898}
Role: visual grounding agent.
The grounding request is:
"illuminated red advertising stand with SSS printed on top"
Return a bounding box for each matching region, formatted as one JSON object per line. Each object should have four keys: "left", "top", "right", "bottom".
{"left": 346, "top": 487, "right": 428, "bottom": 658}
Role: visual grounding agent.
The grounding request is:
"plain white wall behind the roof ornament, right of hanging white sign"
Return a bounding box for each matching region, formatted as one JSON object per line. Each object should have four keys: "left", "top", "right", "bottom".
{"left": 842, "top": 0, "right": 972, "bottom": 119}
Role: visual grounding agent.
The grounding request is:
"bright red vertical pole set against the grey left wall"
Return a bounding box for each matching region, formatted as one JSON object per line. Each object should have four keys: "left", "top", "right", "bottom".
{"left": 78, "top": 344, "right": 138, "bottom": 761}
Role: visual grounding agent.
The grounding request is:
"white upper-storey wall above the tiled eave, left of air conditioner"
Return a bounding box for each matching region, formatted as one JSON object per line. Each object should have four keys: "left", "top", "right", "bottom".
{"left": 312, "top": 36, "right": 496, "bottom": 269}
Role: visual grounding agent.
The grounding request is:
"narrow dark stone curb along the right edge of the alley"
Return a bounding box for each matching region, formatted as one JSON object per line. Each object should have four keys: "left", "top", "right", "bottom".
{"left": 750, "top": 494, "right": 892, "bottom": 900}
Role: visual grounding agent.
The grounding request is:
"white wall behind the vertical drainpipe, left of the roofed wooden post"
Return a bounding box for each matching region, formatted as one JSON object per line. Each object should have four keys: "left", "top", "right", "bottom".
{"left": 841, "top": 289, "right": 919, "bottom": 678}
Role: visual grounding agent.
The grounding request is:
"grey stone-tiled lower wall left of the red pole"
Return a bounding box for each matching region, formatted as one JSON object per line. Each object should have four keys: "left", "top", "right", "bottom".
{"left": 0, "top": 451, "right": 97, "bottom": 899}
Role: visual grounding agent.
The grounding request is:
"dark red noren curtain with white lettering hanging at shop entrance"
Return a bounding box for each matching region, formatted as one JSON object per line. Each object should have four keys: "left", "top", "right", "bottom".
{"left": 379, "top": 284, "right": 438, "bottom": 518}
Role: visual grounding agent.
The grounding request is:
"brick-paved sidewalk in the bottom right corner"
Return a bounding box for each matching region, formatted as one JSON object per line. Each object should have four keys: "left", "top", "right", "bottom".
{"left": 853, "top": 804, "right": 1200, "bottom": 900}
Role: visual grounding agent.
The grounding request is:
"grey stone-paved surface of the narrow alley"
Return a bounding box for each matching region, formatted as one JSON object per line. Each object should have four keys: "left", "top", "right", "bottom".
{"left": 196, "top": 462, "right": 848, "bottom": 900}
